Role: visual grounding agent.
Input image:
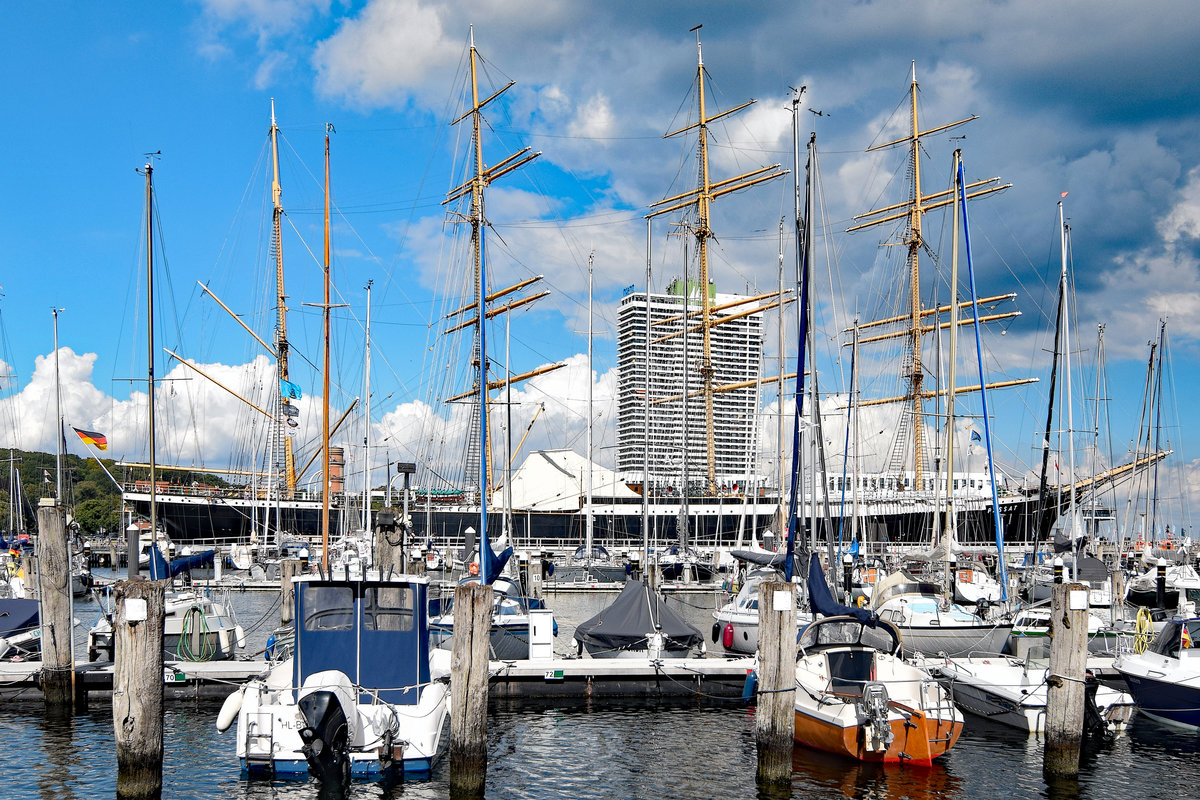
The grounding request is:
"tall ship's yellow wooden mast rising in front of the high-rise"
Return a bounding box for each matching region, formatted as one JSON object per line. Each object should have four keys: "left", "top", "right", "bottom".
{"left": 646, "top": 25, "right": 787, "bottom": 494}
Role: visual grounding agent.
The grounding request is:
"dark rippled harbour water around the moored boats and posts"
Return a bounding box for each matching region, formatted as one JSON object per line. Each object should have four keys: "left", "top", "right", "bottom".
{"left": 11, "top": 582, "right": 1200, "bottom": 800}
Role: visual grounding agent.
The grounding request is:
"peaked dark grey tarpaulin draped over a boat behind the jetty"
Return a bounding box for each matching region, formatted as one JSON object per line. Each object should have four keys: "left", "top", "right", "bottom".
{"left": 575, "top": 579, "right": 704, "bottom": 650}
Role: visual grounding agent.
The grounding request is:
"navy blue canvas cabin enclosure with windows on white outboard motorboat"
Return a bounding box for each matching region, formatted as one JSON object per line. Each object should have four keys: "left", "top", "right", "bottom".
{"left": 293, "top": 573, "right": 430, "bottom": 705}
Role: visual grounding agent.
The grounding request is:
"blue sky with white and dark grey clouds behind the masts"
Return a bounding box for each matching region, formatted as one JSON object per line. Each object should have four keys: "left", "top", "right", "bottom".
{"left": 0, "top": 0, "right": 1200, "bottom": 532}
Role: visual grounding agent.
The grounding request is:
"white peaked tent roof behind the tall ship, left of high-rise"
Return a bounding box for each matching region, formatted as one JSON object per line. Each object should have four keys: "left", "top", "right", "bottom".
{"left": 492, "top": 450, "right": 641, "bottom": 511}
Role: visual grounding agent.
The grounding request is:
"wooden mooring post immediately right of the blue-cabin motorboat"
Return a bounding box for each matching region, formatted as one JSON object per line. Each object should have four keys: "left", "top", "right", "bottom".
{"left": 450, "top": 584, "right": 492, "bottom": 798}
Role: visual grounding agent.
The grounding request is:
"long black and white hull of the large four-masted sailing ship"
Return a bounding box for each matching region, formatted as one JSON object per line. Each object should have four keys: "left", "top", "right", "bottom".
{"left": 122, "top": 479, "right": 1055, "bottom": 547}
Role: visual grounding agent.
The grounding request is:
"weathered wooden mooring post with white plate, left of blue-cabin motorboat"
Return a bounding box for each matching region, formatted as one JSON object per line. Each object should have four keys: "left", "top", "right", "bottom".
{"left": 113, "top": 581, "right": 167, "bottom": 800}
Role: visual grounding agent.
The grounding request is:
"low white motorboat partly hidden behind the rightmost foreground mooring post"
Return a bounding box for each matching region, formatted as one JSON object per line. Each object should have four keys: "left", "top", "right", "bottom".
{"left": 917, "top": 656, "right": 1135, "bottom": 735}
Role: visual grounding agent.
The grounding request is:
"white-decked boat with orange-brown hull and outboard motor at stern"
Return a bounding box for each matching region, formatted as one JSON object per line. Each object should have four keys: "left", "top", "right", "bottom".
{"left": 794, "top": 615, "right": 964, "bottom": 765}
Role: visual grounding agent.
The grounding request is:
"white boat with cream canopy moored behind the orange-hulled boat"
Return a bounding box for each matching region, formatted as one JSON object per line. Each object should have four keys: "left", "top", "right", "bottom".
{"left": 872, "top": 570, "right": 1013, "bottom": 656}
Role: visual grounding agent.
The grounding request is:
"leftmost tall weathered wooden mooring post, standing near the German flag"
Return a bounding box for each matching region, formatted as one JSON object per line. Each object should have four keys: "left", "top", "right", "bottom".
{"left": 37, "top": 505, "right": 74, "bottom": 712}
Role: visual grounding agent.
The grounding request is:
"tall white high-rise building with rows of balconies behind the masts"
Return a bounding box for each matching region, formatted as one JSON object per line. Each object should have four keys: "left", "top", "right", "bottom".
{"left": 617, "top": 281, "right": 762, "bottom": 491}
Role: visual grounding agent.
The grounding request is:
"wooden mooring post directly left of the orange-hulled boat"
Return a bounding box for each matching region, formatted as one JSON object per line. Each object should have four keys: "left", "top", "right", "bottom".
{"left": 755, "top": 582, "right": 796, "bottom": 784}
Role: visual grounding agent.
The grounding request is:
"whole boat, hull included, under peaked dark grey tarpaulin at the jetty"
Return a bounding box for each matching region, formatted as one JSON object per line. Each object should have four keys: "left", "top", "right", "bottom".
{"left": 575, "top": 579, "right": 704, "bottom": 660}
